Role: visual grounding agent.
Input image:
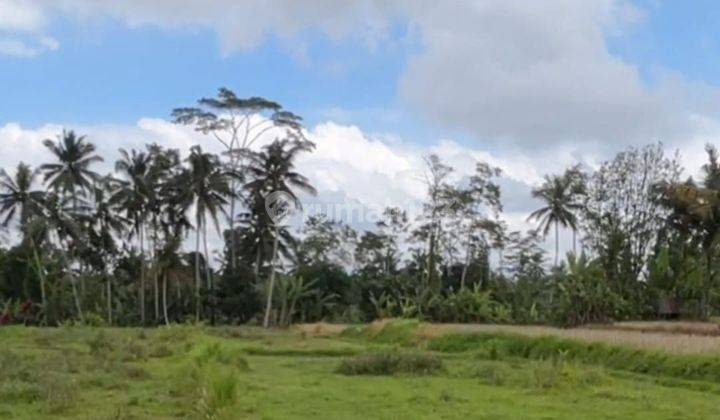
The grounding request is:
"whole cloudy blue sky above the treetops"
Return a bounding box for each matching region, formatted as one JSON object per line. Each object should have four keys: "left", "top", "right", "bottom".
{"left": 0, "top": 0, "right": 720, "bottom": 256}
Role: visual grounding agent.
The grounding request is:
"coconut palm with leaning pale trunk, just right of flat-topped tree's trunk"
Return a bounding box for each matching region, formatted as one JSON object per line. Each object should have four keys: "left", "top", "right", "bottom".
{"left": 245, "top": 139, "right": 316, "bottom": 328}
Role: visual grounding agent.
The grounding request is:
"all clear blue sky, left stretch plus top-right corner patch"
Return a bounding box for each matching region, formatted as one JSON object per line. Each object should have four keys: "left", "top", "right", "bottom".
{"left": 0, "top": 0, "right": 720, "bottom": 148}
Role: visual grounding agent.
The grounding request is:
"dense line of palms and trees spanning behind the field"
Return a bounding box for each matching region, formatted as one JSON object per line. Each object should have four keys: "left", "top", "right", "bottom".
{"left": 0, "top": 89, "right": 720, "bottom": 326}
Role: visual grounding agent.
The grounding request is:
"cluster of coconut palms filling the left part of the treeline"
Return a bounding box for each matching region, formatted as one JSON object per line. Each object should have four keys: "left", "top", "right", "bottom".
{"left": 0, "top": 124, "right": 314, "bottom": 324}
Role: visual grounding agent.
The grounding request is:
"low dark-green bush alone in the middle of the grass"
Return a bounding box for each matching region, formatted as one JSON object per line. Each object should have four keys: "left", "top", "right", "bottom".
{"left": 337, "top": 352, "right": 443, "bottom": 376}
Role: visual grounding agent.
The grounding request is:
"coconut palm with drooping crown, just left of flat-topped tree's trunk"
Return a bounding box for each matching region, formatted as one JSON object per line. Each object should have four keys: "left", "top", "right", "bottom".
{"left": 175, "top": 146, "right": 233, "bottom": 321}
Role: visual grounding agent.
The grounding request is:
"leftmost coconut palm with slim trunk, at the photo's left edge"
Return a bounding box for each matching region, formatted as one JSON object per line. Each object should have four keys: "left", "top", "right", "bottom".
{"left": 0, "top": 162, "right": 46, "bottom": 308}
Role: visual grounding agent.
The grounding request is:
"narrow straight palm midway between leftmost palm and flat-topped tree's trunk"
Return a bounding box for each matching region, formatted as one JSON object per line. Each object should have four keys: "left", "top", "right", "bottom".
{"left": 111, "top": 149, "right": 150, "bottom": 324}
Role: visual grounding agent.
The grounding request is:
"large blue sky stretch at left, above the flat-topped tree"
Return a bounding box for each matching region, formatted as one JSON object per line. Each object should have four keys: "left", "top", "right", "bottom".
{"left": 0, "top": 13, "right": 434, "bottom": 138}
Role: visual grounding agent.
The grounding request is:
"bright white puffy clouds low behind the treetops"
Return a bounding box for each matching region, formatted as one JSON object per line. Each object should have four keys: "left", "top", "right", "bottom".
{"left": 0, "top": 119, "right": 540, "bottom": 226}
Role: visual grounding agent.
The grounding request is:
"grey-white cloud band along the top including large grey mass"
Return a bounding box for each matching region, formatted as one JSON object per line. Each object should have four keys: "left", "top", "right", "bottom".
{"left": 7, "top": 0, "right": 708, "bottom": 151}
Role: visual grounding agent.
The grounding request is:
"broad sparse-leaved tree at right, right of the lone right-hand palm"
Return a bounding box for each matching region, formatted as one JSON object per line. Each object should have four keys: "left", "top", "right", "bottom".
{"left": 580, "top": 143, "right": 682, "bottom": 300}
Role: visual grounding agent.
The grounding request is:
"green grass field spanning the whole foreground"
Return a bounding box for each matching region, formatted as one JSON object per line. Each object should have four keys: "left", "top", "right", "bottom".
{"left": 0, "top": 322, "right": 720, "bottom": 419}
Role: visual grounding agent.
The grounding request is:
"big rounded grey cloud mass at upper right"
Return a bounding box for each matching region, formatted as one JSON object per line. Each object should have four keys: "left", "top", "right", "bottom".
{"left": 400, "top": 0, "right": 685, "bottom": 148}
